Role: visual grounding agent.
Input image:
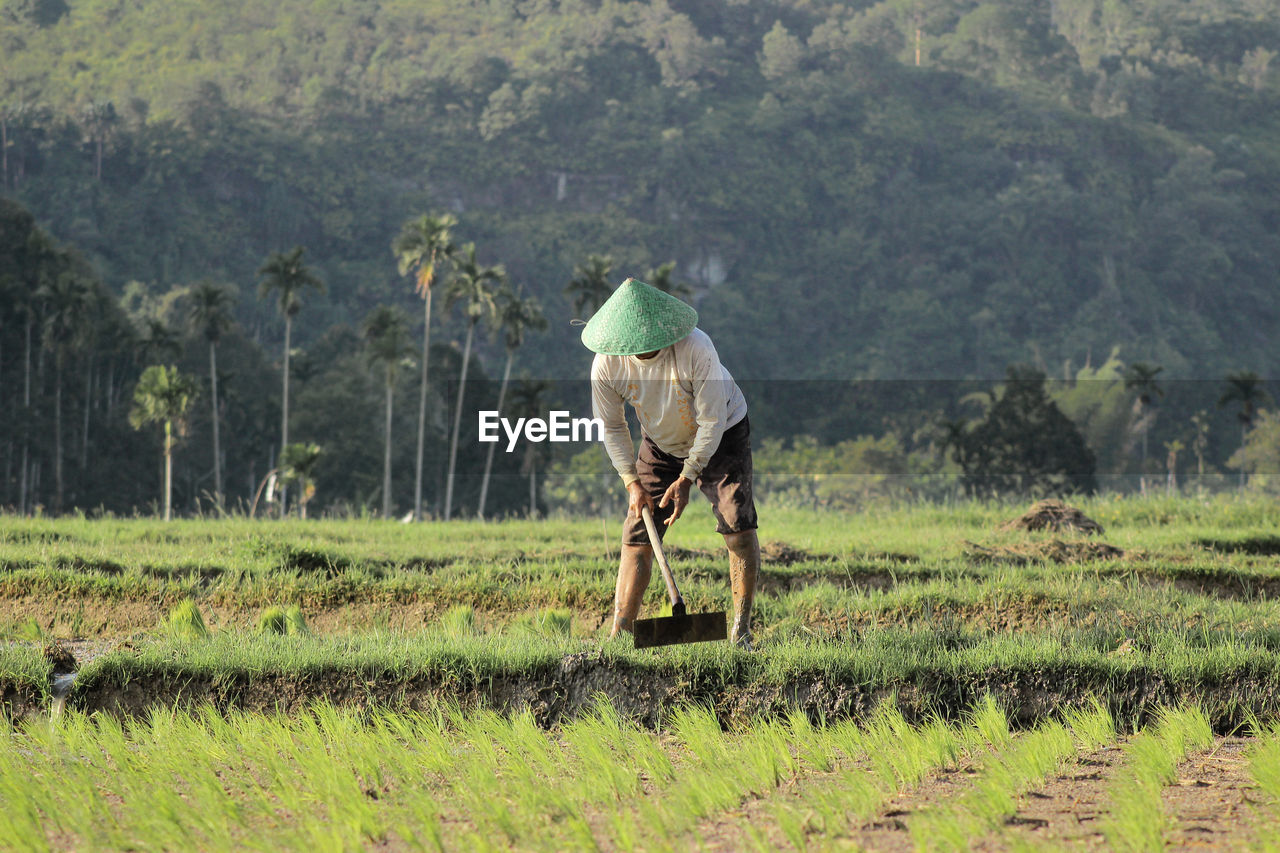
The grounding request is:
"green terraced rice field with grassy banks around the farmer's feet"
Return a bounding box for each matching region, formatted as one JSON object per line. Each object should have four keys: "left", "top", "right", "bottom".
{"left": 0, "top": 497, "right": 1280, "bottom": 850}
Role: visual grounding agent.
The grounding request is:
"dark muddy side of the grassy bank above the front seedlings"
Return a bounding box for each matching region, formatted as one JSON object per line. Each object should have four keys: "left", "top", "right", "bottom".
{"left": 52, "top": 652, "right": 1280, "bottom": 733}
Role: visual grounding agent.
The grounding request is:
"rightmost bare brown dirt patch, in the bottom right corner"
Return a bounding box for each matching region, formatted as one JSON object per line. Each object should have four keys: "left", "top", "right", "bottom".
{"left": 1161, "top": 738, "right": 1275, "bottom": 850}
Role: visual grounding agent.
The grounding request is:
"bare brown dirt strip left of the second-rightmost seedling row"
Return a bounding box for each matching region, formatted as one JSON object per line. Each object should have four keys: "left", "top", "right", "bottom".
{"left": 973, "top": 743, "right": 1124, "bottom": 852}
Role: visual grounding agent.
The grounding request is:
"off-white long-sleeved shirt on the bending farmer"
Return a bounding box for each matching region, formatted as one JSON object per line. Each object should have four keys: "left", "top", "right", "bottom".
{"left": 591, "top": 329, "right": 746, "bottom": 485}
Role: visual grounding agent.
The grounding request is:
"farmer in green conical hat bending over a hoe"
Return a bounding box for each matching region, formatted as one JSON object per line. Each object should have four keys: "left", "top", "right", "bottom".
{"left": 582, "top": 278, "right": 760, "bottom": 648}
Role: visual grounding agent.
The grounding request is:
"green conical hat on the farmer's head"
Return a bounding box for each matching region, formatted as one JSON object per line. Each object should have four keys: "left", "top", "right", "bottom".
{"left": 582, "top": 278, "right": 698, "bottom": 355}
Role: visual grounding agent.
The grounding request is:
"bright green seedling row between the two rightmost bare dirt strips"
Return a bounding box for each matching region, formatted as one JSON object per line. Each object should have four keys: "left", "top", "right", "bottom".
{"left": 1102, "top": 707, "right": 1213, "bottom": 850}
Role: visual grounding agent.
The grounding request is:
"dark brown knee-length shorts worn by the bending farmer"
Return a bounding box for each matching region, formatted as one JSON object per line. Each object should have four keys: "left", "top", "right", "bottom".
{"left": 622, "top": 418, "right": 756, "bottom": 546}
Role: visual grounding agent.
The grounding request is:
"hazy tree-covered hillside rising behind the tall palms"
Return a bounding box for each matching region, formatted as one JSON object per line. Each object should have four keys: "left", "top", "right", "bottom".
{"left": 0, "top": 0, "right": 1280, "bottom": 512}
